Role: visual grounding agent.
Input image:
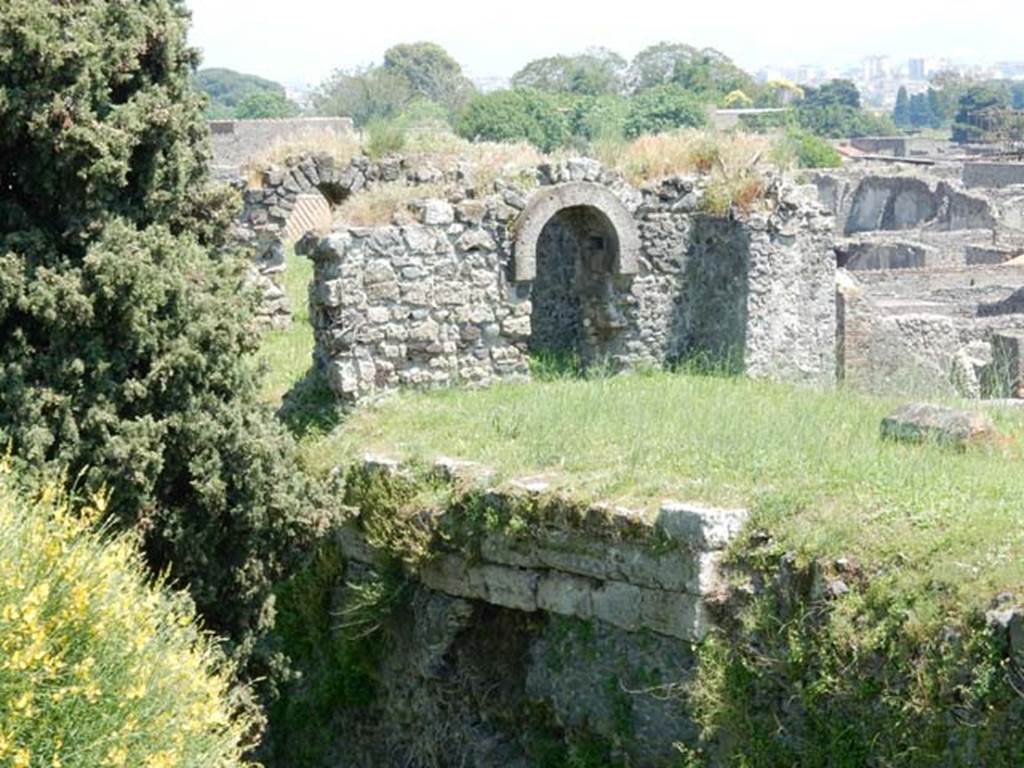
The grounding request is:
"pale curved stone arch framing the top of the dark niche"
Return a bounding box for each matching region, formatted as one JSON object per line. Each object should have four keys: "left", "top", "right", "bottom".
{"left": 514, "top": 181, "right": 640, "bottom": 282}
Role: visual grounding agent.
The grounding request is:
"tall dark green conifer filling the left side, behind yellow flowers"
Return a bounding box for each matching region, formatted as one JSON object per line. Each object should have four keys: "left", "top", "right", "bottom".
{"left": 0, "top": 0, "right": 316, "bottom": 684}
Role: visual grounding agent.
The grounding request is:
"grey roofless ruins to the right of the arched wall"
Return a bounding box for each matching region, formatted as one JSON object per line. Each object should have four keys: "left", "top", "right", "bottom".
{"left": 814, "top": 166, "right": 1024, "bottom": 397}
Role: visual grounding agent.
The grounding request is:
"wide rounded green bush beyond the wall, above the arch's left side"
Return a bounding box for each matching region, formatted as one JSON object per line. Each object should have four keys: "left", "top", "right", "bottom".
{"left": 455, "top": 89, "right": 571, "bottom": 152}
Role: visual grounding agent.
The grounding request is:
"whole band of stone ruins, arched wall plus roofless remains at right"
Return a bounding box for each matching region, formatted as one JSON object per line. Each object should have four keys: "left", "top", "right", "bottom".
{"left": 228, "top": 128, "right": 1024, "bottom": 401}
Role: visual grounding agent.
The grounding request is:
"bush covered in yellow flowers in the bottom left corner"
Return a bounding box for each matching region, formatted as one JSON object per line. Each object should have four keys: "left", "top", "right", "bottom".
{"left": 0, "top": 466, "right": 254, "bottom": 768}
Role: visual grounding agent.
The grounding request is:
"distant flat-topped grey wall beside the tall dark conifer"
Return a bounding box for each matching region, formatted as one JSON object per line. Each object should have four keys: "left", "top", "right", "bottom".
{"left": 209, "top": 118, "right": 355, "bottom": 177}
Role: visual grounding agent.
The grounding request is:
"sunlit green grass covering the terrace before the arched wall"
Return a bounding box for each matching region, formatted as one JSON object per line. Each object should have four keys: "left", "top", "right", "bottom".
{"left": 306, "top": 373, "right": 1024, "bottom": 626}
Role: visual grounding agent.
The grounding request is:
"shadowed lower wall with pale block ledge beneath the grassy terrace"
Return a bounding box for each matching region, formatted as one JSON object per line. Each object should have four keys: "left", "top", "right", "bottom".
{"left": 323, "top": 456, "right": 748, "bottom": 768}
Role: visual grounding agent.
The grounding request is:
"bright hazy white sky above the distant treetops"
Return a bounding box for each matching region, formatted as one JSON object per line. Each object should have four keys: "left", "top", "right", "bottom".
{"left": 186, "top": 0, "right": 1024, "bottom": 84}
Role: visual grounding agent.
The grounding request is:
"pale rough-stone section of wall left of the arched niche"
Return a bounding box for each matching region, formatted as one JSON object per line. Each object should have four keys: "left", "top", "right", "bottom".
{"left": 310, "top": 200, "right": 530, "bottom": 399}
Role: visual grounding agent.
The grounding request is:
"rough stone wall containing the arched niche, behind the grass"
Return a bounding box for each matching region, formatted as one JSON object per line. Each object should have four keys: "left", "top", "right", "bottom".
{"left": 312, "top": 160, "right": 835, "bottom": 399}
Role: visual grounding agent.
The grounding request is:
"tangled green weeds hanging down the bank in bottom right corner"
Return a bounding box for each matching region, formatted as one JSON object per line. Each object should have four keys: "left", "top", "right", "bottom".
{"left": 688, "top": 545, "right": 1024, "bottom": 768}
